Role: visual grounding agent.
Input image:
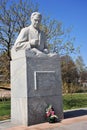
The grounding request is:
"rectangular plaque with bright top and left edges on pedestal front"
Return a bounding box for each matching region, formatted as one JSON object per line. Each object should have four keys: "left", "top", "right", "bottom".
{"left": 34, "top": 71, "right": 56, "bottom": 90}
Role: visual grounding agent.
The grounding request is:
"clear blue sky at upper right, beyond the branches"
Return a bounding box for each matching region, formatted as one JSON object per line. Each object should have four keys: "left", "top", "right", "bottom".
{"left": 34, "top": 0, "right": 87, "bottom": 66}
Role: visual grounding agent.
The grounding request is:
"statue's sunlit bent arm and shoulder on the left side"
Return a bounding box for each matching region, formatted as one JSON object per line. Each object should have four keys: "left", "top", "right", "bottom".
{"left": 14, "top": 28, "right": 31, "bottom": 51}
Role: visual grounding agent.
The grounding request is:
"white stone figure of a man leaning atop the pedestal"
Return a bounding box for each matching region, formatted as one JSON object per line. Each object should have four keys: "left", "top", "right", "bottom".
{"left": 13, "top": 12, "right": 48, "bottom": 55}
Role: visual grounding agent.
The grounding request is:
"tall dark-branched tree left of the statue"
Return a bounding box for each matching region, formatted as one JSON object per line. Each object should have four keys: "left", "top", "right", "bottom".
{"left": 0, "top": 0, "right": 38, "bottom": 82}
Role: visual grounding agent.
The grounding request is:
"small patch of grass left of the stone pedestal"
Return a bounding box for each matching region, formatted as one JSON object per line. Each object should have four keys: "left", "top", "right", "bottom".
{"left": 0, "top": 100, "right": 11, "bottom": 121}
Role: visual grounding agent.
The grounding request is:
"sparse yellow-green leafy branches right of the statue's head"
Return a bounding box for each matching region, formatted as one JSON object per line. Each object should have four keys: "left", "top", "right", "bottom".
{"left": 42, "top": 16, "right": 76, "bottom": 55}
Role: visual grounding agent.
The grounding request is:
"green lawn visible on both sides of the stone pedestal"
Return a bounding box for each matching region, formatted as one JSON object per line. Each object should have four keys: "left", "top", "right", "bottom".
{"left": 0, "top": 93, "right": 87, "bottom": 120}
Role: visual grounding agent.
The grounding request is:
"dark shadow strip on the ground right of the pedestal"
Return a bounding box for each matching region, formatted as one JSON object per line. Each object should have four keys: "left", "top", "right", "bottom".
{"left": 64, "top": 109, "right": 87, "bottom": 119}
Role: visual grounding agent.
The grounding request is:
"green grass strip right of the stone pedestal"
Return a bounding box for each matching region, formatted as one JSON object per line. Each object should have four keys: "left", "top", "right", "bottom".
{"left": 63, "top": 93, "right": 87, "bottom": 110}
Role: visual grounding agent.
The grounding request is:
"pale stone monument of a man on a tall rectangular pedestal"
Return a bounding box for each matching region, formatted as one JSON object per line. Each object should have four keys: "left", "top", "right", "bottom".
{"left": 11, "top": 12, "right": 63, "bottom": 126}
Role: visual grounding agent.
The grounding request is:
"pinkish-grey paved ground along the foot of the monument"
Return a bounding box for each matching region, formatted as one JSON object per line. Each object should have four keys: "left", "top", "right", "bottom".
{"left": 0, "top": 115, "right": 87, "bottom": 130}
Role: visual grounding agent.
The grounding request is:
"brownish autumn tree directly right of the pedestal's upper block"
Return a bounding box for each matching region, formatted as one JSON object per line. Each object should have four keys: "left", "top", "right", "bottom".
{"left": 61, "top": 55, "right": 79, "bottom": 92}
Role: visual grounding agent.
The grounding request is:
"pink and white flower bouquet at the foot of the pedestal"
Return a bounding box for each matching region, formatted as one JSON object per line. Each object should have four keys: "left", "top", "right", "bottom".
{"left": 46, "top": 105, "right": 58, "bottom": 123}
